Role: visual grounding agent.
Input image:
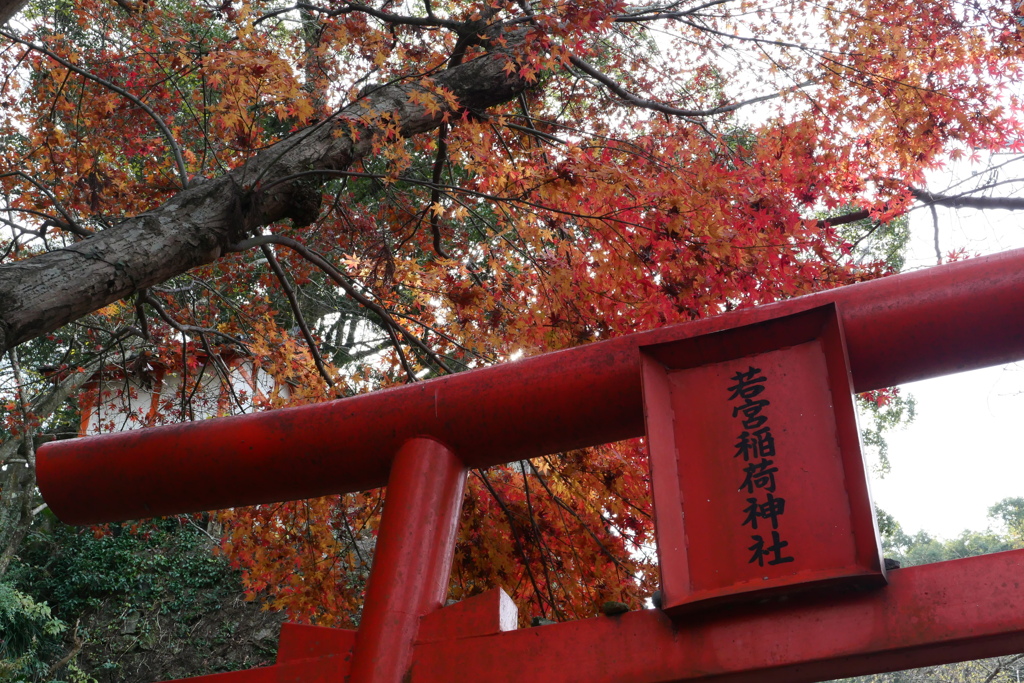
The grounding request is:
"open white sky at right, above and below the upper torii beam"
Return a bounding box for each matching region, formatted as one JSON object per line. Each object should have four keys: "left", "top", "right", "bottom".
{"left": 871, "top": 165, "right": 1024, "bottom": 539}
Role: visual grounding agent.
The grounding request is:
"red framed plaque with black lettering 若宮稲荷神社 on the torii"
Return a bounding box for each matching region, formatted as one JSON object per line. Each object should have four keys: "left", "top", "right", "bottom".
{"left": 640, "top": 305, "right": 886, "bottom": 612}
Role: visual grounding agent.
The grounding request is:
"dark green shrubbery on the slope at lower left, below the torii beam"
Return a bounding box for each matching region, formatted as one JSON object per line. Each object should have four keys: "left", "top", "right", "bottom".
{"left": 0, "top": 517, "right": 260, "bottom": 683}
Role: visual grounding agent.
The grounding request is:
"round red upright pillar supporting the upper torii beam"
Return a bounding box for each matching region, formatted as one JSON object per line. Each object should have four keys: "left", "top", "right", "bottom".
{"left": 349, "top": 437, "right": 466, "bottom": 683}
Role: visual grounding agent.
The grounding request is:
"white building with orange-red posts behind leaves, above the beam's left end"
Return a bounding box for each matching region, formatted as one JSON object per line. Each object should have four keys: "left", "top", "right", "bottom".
{"left": 79, "top": 352, "right": 291, "bottom": 436}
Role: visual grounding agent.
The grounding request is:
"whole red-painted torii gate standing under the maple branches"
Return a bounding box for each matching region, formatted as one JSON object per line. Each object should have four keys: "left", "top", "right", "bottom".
{"left": 37, "top": 250, "right": 1024, "bottom": 683}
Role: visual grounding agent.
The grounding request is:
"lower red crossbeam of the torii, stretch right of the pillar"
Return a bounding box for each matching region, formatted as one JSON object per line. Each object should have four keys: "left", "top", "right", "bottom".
{"left": 410, "top": 551, "right": 1024, "bottom": 683}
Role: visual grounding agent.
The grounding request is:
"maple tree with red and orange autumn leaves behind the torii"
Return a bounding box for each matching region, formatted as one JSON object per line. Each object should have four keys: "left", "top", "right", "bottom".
{"left": 0, "top": 0, "right": 1024, "bottom": 624}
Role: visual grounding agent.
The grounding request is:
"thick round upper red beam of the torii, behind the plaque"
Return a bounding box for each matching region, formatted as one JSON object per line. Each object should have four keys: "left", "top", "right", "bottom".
{"left": 37, "top": 245, "right": 1024, "bottom": 524}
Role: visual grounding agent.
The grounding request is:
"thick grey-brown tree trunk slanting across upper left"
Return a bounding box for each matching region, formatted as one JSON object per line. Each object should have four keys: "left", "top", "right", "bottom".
{"left": 0, "top": 38, "right": 526, "bottom": 352}
